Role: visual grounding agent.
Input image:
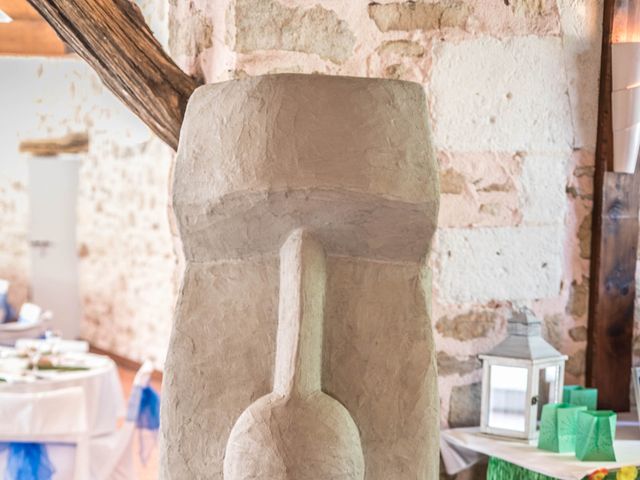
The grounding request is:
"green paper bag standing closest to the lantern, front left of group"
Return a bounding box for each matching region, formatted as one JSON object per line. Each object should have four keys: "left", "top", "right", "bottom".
{"left": 538, "top": 403, "right": 587, "bottom": 453}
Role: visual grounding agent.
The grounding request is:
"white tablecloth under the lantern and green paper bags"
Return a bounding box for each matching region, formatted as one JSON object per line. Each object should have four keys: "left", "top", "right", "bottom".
{"left": 440, "top": 413, "right": 640, "bottom": 480}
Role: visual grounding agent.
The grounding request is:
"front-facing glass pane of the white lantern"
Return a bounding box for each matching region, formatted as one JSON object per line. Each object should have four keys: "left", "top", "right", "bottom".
{"left": 488, "top": 365, "right": 528, "bottom": 432}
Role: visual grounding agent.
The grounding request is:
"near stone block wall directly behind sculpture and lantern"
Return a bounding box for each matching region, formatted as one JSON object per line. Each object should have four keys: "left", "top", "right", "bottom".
{"left": 170, "top": 0, "right": 602, "bottom": 432}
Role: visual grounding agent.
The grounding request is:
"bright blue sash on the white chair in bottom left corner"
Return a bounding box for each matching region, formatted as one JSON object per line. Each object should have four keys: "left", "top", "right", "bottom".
{"left": 0, "top": 442, "right": 55, "bottom": 480}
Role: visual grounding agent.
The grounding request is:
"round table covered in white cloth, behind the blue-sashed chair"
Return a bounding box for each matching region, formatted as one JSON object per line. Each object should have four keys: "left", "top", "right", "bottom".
{"left": 0, "top": 349, "right": 126, "bottom": 436}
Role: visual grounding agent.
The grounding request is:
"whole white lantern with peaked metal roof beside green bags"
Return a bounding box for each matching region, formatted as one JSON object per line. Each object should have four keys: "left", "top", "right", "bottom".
{"left": 480, "top": 309, "right": 567, "bottom": 440}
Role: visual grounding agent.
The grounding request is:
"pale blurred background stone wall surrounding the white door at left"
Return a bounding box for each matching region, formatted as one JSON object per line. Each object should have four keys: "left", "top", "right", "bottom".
{"left": 0, "top": 0, "right": 177, "bottom": 365}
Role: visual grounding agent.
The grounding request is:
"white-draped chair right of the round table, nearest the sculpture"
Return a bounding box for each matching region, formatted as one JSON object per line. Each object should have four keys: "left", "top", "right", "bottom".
{"left": 89, "top": 361, "right": 158, "bottom": 480}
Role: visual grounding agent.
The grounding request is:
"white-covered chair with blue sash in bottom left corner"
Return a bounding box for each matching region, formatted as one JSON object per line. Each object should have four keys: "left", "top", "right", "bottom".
{"left": 0, "top": 387, "right": 90, "bottom": 480}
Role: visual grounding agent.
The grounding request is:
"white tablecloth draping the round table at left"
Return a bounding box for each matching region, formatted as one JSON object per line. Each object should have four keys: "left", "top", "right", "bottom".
{"left": 0, "top": 353, "right": 126, "bottom": 435}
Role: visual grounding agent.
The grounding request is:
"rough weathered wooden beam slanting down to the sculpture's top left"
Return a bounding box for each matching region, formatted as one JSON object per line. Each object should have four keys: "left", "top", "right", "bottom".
{"left": 29, "top": 0, "right": 198, "bottom": 150}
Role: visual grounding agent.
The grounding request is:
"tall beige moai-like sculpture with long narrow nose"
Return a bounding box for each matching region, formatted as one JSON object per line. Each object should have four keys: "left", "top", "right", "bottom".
{"left": 161, "top": 75, "right": 439, "bottom": 480}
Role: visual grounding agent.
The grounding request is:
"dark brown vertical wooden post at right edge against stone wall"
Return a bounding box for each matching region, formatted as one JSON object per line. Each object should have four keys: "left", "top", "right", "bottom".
{"left": 587, "top": 0, "right": 640, "bottom": 411}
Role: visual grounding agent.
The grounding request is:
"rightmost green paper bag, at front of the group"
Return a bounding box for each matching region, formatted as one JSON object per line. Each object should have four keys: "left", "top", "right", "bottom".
{"left": 576, "top": 410, "right": 618, "bottom": 462}
